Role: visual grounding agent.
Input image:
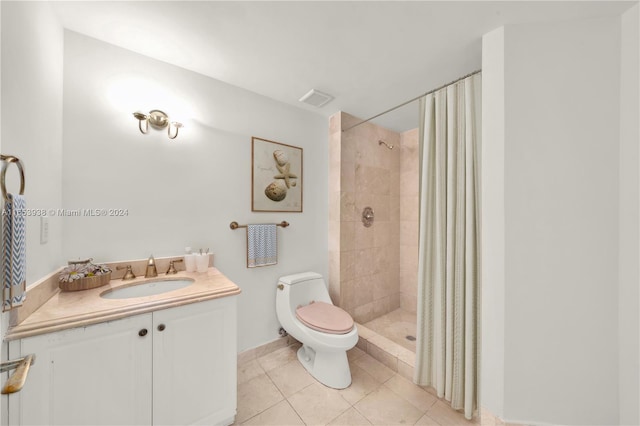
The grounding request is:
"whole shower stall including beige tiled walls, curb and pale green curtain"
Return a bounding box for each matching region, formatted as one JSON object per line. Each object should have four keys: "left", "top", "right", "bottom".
{"left": 329, "top": 71, "right": 481, "bottom": 419}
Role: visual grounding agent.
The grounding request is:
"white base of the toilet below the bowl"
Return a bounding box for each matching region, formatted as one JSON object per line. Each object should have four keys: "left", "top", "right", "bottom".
{"left": 298, "top": 345, "right": 351, "bottom": 389}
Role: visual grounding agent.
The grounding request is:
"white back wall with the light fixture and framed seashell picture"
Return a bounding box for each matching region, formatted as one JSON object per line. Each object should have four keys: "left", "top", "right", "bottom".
{"left": 63, "top": 31, "right": 328, "bottom": 350}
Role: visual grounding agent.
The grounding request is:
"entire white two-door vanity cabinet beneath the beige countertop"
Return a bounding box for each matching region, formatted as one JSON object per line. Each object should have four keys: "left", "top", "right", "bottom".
{"left": 8, "top": 297, "right": 237, "bottom": 425}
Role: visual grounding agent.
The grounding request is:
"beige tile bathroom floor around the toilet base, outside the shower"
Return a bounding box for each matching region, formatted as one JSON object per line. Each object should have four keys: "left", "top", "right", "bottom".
{"left": 236, "top": 345, "right": 484, "bottom": 426}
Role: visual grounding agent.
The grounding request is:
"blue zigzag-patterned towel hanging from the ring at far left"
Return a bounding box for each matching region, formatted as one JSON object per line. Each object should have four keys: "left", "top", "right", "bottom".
{"left": 2, "top": 194, "right": 27, "bottom": 311}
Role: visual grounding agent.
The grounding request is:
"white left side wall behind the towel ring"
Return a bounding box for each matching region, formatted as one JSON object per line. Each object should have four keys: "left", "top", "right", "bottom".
{"left": 1, "top": 2, "right": 63, "bottom": 284}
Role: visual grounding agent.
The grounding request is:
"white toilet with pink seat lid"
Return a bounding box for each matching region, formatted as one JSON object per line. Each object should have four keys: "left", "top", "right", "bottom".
{"left": 276, "top": 272, "right": 358, "bottom": 389}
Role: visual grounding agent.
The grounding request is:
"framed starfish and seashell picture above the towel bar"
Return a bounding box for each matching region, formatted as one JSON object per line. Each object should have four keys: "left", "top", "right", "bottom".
{"left": 251, "top": 136, "right": 303, "bottom": 213}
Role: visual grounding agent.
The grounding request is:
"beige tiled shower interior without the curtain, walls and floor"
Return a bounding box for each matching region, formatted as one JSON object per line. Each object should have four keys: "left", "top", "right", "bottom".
{"left": 329, "top": 112, "right": 419, "bottom": 352}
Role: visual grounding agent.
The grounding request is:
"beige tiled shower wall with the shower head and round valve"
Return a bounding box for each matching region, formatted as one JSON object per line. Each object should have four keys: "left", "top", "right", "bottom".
{"left": 329, "top": 113, "right": 401, "bottom": 323}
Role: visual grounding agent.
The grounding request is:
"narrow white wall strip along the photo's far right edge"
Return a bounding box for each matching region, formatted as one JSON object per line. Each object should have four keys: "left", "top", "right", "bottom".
{"left": 618, "top": 5, "right": 640, "bottom": 425}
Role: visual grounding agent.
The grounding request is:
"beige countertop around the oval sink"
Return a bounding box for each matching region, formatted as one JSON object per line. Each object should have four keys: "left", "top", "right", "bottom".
{"left": 5, "top": 267, "right": 240, "bottom": 340}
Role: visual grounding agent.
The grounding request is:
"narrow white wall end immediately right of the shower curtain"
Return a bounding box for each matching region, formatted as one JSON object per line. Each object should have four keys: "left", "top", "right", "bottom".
{"left": 480, "top": 27, "right": 505, "bottom": 418}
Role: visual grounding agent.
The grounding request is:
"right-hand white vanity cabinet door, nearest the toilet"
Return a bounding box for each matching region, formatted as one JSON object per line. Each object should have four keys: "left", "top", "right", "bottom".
{"left": 153, "top": 297, "right": 237, "bottom": 425}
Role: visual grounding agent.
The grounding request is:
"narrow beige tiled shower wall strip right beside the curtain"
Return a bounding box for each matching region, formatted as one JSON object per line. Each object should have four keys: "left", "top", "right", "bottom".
{"left": 400, "top": 129, "right": 419, "bottom": 312}
